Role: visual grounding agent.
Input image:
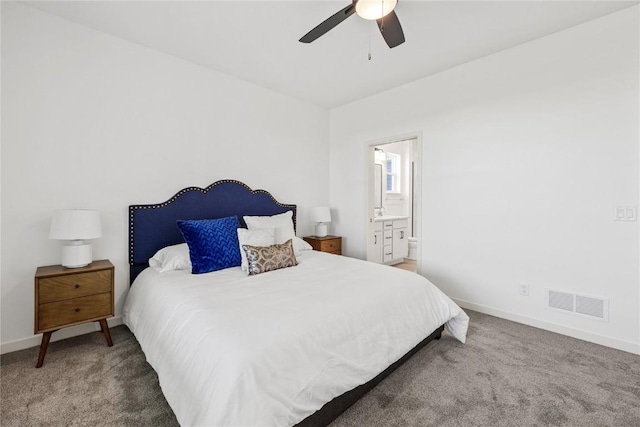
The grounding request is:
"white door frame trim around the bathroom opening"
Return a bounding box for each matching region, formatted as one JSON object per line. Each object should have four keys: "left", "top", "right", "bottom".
{"left": 363, "top": 131, "right": 424, "bottom": 274}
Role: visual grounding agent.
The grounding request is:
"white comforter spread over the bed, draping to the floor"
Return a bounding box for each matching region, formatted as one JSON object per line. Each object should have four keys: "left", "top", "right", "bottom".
{"left": 124, "top": 251, "right": 469, "bottom": 426}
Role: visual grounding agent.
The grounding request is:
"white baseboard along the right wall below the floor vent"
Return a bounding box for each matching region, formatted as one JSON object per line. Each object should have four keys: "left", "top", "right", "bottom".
{"left": 452, "top": 298, "right": 640, "bottom": 354}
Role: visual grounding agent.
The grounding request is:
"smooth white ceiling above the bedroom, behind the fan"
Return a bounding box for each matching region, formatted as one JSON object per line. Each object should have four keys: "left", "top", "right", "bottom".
{"left": 22, "top": 0, "right": 638, "bottom": 108}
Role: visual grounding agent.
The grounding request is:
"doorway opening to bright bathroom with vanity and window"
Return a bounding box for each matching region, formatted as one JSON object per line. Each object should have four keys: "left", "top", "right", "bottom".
{"left": 366, "top": 134, "right": 422, "bottom": 272}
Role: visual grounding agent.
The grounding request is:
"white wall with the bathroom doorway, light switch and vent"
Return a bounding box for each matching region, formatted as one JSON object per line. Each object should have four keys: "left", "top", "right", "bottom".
{"left": 330, "top": 7, "right": 640, "bottom": 352}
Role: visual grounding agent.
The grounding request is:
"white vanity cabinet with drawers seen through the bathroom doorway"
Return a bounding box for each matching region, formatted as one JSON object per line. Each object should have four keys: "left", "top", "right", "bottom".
{"left": 373, "top": 217, "right": 409, "bottom": 264}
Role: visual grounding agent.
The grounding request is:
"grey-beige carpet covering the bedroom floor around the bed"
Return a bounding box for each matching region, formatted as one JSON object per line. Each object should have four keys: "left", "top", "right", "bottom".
{"left": 0, "top": 312, "right": 640, "bottom": 427}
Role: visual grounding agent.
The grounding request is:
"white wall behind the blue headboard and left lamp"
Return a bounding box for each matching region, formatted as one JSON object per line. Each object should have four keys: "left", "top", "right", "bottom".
{"left": 1, "top": 2, "right": 329, "bottom": 352}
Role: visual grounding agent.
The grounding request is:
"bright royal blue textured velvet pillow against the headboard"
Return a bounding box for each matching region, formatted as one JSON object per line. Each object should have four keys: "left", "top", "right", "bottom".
{"left": 178, "top": 216, "right": 242, "bottom": 274}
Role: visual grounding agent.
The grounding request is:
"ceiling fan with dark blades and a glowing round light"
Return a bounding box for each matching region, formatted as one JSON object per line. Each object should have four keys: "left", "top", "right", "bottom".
{"left": 300, "top": 0, "right": 404, "bottom": 48}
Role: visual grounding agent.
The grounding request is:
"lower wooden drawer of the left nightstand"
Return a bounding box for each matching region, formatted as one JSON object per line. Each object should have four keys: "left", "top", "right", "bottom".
{"left": 38, "top": 292, "right": 113, "bottom": 331}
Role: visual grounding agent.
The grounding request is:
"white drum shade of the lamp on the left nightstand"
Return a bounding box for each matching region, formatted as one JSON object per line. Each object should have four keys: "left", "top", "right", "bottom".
{"left": 49, "top": 209, "right": 102, "bottom": 240}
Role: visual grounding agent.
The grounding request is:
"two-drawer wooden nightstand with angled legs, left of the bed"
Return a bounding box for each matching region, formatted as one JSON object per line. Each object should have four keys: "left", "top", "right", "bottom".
{"left": 33, "top": 259, "right": 114, "bottom": 368}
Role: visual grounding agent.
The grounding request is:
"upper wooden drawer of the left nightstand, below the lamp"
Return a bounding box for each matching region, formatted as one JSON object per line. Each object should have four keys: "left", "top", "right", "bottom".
{"left": 38, "top": 270, "right": 113, "bottom": 304}
